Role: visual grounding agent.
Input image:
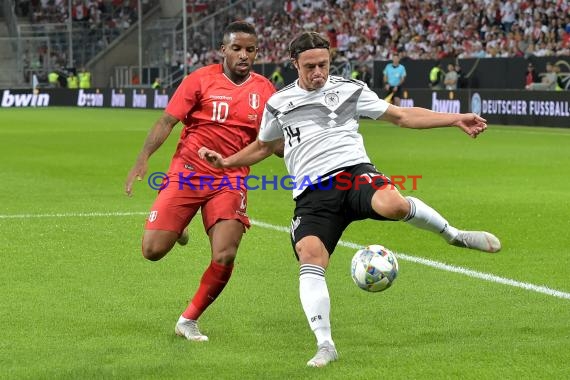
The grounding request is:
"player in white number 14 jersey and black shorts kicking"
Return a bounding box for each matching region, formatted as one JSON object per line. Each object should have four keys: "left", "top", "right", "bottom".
{"left": 199, "top": 32, "right": 501, "bottom": 367}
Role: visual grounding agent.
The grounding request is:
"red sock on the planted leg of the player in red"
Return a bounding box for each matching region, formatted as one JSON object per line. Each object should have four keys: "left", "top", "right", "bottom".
{"left": 182, "top": 261, "right": 234, "bottom": 320}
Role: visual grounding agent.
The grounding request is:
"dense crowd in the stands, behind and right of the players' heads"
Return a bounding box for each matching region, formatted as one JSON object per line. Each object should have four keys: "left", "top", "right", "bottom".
{"left": 181, "top": 0, "right": 570, "bottom": 66}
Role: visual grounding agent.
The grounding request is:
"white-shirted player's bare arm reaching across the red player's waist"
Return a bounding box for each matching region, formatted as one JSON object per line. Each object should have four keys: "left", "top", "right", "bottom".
{"left": 198, "top": 139, "right": 283, "bottom": 169}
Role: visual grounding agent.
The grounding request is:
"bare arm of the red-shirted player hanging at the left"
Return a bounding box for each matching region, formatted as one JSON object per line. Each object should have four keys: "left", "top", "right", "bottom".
{"left": 125, "top": 112, "right": 178, "bottom": 196}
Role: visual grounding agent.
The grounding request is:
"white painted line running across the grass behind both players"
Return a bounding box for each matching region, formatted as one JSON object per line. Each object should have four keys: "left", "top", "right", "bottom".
{"left": 0, "top": 212, "right": 570, "bottom": 299}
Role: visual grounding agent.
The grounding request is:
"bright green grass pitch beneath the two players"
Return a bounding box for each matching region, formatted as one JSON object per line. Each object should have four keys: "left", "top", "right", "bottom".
{"left": 0, "top": 108, "right": 570, "bottom": 380}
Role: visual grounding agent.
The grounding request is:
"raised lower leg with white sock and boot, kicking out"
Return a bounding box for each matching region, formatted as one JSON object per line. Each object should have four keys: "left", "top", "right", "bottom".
{"left": 403, "top": 197, "right": 501, "bottom": 253}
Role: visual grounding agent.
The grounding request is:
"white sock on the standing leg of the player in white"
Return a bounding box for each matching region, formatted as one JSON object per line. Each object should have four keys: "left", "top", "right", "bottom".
{"left": 299, "top": 264, "right": 334, "bottom": 346}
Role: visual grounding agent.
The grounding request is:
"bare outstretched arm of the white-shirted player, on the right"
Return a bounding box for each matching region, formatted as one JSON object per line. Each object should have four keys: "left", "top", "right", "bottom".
{"left": 380, "top": 105, "right": 487, "bottom": 138}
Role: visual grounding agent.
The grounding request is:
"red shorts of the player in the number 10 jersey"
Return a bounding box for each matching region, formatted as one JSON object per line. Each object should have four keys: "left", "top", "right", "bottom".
{"left": 145, "top": 177, "right": 250, "bottom": 234}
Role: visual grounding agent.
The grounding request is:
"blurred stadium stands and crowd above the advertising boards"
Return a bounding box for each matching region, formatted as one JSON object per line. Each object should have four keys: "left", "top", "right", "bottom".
{"left": 0, "top": 0, "right": 570, "bottom": 89}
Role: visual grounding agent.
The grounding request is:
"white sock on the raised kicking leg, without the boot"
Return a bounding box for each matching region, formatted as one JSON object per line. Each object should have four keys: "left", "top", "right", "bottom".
{"left": 402, "top": 197, "right": 459, "bottom": 242}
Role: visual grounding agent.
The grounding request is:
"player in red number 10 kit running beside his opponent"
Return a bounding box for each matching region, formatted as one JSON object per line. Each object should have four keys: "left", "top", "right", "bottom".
{"left": 125, "top": 21, "right": 275, "bottom": 341}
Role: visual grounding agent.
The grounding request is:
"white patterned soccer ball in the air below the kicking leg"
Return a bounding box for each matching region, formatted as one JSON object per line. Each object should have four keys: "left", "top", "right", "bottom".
{"left": 351, "top": 245, "right": 398, "bottom": 292}
